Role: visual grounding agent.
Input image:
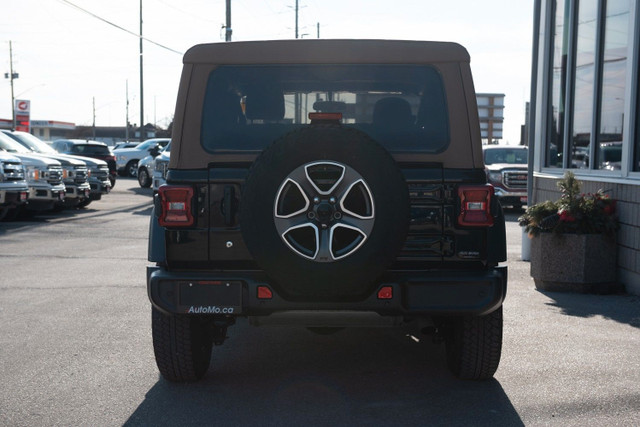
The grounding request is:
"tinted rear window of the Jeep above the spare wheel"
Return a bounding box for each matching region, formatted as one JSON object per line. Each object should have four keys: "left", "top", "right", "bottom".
{"left": 201, "top": 64, "right": 449, "bottom": 153}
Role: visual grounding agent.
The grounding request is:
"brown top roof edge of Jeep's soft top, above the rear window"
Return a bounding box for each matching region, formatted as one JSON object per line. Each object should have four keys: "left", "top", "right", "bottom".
{"left": 184, "top": 39, "right": 469, "bottom": 64}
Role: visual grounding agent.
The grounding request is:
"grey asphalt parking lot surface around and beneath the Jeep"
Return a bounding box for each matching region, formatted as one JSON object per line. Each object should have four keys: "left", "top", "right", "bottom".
{"left": 0, "top": 179, "right": 640, "bottom": 426}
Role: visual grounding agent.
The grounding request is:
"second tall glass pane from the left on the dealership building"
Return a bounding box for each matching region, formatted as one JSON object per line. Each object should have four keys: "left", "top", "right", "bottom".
{"left": 569, "top": 0, "right": 598, "bottom": 169}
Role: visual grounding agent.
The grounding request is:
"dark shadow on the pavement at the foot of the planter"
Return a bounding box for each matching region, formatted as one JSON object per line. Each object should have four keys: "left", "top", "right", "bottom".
{"left": 540, "top": 291, "right": 640, "bottom": 328}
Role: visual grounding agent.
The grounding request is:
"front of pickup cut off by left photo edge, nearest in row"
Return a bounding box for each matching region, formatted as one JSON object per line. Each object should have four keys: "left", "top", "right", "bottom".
{"left": 0, "top": 151, "right": 29, "bottom": 221}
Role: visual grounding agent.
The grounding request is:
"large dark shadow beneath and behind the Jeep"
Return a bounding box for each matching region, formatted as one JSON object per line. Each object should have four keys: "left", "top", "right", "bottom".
{"left": 125, "top": 325, "right": 523, "bottom": 426}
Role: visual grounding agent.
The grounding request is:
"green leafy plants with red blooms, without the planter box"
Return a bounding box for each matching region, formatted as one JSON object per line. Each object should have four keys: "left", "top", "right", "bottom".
{"left": 518, "top": 171, "right": 618, "bottom": 237}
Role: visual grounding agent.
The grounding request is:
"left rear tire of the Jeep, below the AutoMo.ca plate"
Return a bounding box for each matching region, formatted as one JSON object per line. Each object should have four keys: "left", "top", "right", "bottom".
{"left": 151, "top": 307, "right": 213, "bottom": 382}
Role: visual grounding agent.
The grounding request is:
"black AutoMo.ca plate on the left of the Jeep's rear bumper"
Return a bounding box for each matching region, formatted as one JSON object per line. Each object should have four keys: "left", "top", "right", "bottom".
{"left": 178, "top": 280, "right": 242, "bottom": 315}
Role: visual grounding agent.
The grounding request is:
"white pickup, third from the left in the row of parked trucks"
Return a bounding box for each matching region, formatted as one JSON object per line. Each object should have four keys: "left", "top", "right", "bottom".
{"left": 2, "top": 130, "right": 91, "bottom": 208}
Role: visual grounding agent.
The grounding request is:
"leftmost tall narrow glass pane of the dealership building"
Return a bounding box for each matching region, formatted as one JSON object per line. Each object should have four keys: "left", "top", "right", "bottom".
{"left": 545, "top": 0, "right": 569, "bottom": 168}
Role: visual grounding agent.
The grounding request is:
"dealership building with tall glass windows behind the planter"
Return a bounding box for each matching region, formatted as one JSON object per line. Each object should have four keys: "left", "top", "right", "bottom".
{"left": 528, "top": 0, "right": 640, "bottom": 295}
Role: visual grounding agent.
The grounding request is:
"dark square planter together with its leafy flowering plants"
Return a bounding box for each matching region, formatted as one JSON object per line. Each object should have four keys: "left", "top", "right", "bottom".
{"left": 519, "top": 172, "right": 619, "bottom": 293}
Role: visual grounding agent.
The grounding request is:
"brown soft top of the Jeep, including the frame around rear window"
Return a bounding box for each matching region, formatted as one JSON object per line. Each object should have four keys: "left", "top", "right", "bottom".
{"left": 169, "top": 39, "right": 483, "bottom": 169}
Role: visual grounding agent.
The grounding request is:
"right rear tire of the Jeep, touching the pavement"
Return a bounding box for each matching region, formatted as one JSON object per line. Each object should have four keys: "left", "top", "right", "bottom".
{"left": 445, "top": 307, "right": 502, "bottom": 380}
